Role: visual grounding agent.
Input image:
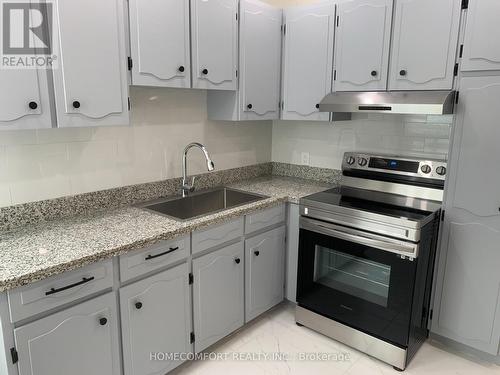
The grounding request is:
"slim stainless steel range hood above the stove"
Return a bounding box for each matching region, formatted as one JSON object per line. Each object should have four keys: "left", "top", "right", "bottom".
{"left": 319, "top": 91, "right": 455, "bottom": 115}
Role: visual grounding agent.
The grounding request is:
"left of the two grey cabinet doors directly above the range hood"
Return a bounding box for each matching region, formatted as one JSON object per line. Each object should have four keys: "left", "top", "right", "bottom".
{"left": 334, "top": 0, "right": 392, "bottom": 91}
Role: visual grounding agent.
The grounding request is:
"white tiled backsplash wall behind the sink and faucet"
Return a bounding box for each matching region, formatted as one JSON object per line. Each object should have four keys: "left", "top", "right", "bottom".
{"left": 0, "top": 88, "right": 272, "bottom": 207}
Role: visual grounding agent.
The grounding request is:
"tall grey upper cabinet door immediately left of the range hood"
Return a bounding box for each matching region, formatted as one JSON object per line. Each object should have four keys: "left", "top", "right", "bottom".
{"left": 281, "top": 2, "right": 335, "bottom": 121}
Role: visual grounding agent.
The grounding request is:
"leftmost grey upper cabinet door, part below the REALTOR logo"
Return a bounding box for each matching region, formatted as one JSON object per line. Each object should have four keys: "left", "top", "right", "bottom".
{"left": 0, "top": 69, "right": 52, "bottom": 130}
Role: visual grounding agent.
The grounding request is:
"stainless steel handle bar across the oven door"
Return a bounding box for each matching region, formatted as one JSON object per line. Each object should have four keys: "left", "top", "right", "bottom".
{"left": 300, "top": 218, "right": 418, "bottom": 258}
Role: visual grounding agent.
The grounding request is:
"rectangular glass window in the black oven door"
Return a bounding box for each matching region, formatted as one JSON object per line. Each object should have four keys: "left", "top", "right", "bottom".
{"left": 314, "top": 246, "right": 391, "bottom": 307}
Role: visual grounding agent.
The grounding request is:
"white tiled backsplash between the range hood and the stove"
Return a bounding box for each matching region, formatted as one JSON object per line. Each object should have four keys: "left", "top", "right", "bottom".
{"left": 272, "top": 114, "right": 453, "bottom": 169}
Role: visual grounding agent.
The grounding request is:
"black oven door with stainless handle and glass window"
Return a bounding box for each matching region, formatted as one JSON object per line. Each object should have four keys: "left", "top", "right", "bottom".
{"left": 297, "top": 217, "right": 418, "bottom": 348}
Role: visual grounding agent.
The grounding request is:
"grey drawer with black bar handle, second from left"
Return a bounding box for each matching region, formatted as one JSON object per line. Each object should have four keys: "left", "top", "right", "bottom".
{"left": 120, "top": 236, "right": 189, "bottom": 282}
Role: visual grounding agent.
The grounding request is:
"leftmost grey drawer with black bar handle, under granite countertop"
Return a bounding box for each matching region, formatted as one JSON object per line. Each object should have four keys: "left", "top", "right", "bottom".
{"left": 8, "top": 260, "right": 113, "bottom": 322}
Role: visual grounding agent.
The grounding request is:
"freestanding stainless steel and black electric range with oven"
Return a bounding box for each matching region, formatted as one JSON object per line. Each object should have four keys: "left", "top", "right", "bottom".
{"left": 296, "top": 153, "right": 446, "bottom": 370}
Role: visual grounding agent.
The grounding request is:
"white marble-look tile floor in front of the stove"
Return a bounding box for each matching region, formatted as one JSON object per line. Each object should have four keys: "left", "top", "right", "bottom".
{"left": 171, "top": 304, "right": 500, "bottom": 375}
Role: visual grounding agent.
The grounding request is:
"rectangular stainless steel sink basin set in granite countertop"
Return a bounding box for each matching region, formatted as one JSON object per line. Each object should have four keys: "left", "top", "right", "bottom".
{"left": 142, "top": 187, "right": 267, "bottom": 220}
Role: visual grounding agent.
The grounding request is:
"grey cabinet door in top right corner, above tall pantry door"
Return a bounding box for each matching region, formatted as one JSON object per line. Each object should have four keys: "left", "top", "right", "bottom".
{"left": 462, "top": 0, "right": 500, "bottom": 71}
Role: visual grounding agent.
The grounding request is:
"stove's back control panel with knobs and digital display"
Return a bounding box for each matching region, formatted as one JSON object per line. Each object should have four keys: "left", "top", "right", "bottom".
{"left": 342, "top": 152, "right": 447, "bottom": 180}
